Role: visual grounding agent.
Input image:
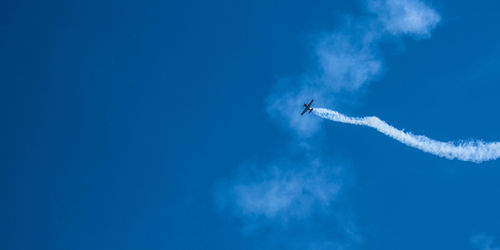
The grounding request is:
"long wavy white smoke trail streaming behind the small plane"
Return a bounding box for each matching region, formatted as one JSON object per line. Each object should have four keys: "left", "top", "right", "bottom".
{"left": 313, "top": 108, "right": 500, "bottom": 163}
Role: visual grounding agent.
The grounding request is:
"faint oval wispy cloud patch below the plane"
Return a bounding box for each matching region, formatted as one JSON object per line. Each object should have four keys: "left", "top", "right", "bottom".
{"left": 219, "top": 160, "right": 342, "bottom": 222}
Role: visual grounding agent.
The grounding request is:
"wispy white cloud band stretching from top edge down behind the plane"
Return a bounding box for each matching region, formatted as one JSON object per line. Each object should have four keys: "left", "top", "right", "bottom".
{"left": 267, "top": 0, "right": 441, "bottom": 137}
